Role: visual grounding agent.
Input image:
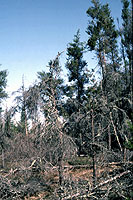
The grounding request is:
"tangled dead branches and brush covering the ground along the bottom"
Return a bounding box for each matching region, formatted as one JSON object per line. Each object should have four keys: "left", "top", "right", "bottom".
{"left": 0, "top": 156, "right": 132, "bottom": 200}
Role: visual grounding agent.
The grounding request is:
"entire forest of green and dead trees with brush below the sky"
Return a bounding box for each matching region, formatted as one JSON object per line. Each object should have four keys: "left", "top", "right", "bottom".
{"left": 0, "top": 0, "right": 133, "bottom": 200}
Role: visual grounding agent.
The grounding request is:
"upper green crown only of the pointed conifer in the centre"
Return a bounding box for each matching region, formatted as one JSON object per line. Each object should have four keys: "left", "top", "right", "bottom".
{"left": 66, "top": 30, "right": 88, "bottom": 103}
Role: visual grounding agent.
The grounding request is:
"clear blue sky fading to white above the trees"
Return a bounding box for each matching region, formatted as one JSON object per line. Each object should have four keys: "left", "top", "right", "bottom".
{"left": 0, "top": 0, "right": 121, "bottom": 106}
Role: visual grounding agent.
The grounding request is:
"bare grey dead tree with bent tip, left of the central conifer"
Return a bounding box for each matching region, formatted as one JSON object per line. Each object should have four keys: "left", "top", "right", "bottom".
{"left": 37, "top": 51, "right": 76, "bottom": 186}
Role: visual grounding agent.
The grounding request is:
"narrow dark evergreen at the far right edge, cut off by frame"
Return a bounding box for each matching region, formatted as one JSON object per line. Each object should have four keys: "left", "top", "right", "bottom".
{"left": 120, "top": 0, "right": 133, "bottom": 96}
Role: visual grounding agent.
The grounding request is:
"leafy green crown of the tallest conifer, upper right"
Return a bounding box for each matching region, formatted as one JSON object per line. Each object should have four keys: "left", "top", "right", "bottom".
{"left": 86, "top": 0, "right": 120, "bottom": 90}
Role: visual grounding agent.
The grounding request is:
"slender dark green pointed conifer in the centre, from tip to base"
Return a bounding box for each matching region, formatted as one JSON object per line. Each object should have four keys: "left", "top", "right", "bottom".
{"left": 64, "top": 30, "right": 89, "bottom": 154}
